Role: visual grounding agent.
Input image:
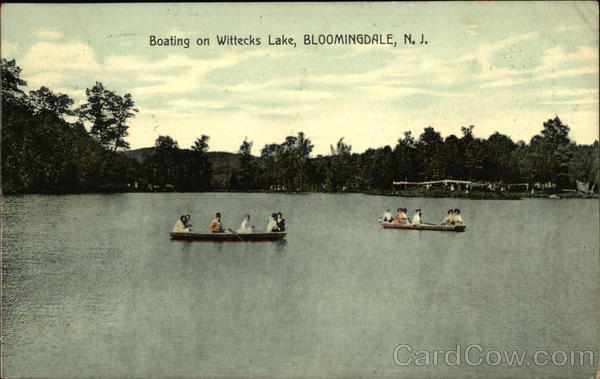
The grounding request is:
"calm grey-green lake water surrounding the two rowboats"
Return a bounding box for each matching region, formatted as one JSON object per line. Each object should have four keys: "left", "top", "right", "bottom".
{"left": 2, "top": 193, "right": 600, "bottom": 378}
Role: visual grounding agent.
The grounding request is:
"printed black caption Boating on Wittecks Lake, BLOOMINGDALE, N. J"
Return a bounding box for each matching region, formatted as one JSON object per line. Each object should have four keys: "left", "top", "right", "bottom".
{"left": 148, "top": 33, "right": 428, "bottom": 49}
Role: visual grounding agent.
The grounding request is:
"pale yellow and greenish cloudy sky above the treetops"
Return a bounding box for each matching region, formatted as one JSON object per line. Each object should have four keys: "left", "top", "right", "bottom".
{"left": 0, "top": 2, "right": 599, "bottom": 155}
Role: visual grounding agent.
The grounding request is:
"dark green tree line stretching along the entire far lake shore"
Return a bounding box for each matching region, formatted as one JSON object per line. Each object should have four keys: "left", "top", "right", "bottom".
{"left": 2, "top": 59, "right": 599, "bottom": 197}
